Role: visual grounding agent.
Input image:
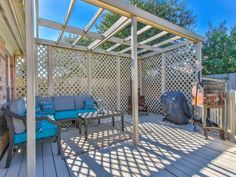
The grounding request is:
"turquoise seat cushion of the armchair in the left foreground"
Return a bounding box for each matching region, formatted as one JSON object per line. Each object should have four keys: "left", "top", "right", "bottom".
{"left": 14, "top": 120, "right": 57, "bottom": 144}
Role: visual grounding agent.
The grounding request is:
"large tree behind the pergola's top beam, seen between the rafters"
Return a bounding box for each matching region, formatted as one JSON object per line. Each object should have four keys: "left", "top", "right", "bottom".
{"left": 96, "top": 0, "right": 195, "bottom": 50}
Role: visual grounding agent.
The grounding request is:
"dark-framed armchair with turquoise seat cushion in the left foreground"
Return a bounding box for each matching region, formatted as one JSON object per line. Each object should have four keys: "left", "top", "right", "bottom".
{"left": 1, "top": 100, "right": 61, "bottom": 168}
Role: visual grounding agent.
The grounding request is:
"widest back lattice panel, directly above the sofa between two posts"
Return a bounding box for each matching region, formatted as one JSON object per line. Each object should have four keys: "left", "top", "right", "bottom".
{"left": 52, "top": 47, "right": 88, "bottom": 95}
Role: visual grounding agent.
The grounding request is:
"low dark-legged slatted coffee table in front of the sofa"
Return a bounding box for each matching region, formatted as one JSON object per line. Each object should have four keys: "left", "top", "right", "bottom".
{"left": 78, "top": 110, "right": 125, "bottom": 141}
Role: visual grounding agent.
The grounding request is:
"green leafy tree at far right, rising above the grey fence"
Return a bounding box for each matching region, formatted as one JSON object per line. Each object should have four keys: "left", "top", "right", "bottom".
{"left": 202, "top": 22, "right": 236, "bottom": 75}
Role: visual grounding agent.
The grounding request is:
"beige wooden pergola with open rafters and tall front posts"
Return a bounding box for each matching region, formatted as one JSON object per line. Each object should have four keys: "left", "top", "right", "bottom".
{"left": 25, "top": 0, "right": 204, "bottom": 176}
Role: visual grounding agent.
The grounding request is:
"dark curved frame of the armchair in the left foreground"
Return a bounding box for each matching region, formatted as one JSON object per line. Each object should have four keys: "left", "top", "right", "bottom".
{"left": 1, "top": 103, "right": 62, "bottom": 168}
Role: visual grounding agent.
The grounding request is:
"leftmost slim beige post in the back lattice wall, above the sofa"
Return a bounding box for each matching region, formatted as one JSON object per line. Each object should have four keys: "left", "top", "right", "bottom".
{"left": 48, "top": 46, "right": 54, "bottom": 96}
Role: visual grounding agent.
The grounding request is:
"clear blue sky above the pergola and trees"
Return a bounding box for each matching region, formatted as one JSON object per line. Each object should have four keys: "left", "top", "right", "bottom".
{"left": 39, "top": 0, "right": 236, "bottom": 40}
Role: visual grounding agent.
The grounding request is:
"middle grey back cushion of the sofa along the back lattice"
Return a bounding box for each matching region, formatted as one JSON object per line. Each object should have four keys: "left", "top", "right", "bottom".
{"left": 54, "top": 96, "right": 75, "bottom": 111}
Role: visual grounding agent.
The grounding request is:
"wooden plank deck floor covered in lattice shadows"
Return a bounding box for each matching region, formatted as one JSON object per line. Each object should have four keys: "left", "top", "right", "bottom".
{"left": 0, "top": 114, "right": 236, "bottom": 177}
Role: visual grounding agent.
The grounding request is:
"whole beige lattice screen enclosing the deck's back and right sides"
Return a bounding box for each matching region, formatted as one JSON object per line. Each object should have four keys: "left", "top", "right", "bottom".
{"left": 16, "top": 45, "right": 196, "bottom": 112}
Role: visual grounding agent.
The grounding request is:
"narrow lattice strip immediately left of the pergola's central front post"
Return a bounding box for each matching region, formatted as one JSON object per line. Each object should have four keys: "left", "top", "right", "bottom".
{"left": 120, "top": 57, "right": 131, "bottom": 111}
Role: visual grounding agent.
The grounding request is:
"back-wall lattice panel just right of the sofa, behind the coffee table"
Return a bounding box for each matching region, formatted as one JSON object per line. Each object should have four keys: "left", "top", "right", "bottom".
{"left": 91, "top": 53, "right": 117, "bottom": 110}
